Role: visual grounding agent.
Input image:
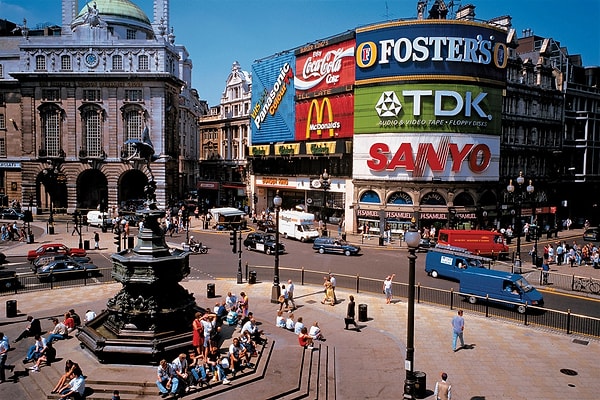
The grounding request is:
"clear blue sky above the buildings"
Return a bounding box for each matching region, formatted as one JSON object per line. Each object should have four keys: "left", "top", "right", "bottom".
{"left": 0, "top": 0, "right": 600, "bottom": 106}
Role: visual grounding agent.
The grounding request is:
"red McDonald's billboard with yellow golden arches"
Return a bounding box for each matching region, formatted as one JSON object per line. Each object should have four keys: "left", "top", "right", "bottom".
{"left": 296, "top": 93, "right": 354, "bottom": 141}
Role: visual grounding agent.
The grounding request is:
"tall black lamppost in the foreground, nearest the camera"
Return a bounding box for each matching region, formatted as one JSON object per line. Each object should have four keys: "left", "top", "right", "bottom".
{"left": 404, "top": 224, "right": 421, "bottom": 399}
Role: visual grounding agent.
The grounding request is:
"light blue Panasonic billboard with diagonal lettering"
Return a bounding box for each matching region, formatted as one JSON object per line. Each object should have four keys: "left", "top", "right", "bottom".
{"left": 250, "top": 54, "right": 295, "bottom": 144}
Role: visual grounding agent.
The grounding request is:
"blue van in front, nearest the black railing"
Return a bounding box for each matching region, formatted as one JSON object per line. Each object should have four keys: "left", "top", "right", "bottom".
{"left": 459, "top": 269, "right": 544, "bottom": 314}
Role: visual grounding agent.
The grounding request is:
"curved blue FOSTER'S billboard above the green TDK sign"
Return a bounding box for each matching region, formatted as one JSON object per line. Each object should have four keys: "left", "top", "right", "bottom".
{"left": 356, "top": 20, "right": 508, "bottom": 83}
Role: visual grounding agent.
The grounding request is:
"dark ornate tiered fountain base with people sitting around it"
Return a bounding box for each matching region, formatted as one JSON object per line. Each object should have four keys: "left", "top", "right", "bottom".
{"left": 77, "top": 210, "right": 203, "bottom": 363}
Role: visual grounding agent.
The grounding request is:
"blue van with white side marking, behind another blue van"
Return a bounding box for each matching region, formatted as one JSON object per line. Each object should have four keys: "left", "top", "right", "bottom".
{"left": 425, "top": 245, "right": 492, "bottom": 281}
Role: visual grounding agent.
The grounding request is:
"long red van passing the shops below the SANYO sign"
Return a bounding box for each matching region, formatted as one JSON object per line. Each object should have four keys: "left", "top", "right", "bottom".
{"left": 438, "top": 229, "right": 508, "bottom": 258}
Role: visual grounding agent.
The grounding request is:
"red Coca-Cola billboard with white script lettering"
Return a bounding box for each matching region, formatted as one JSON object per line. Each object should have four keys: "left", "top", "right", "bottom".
{"left": 294, "top": 39, "right": 354, "bottom": 94}
